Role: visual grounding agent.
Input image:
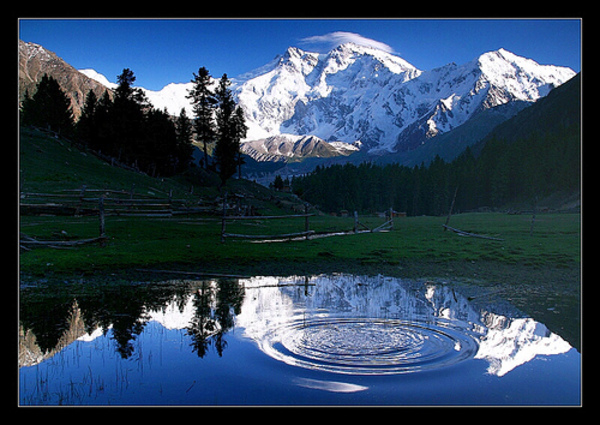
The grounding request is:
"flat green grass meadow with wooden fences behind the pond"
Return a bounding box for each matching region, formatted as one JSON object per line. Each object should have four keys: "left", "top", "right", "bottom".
{"left": 20, "top": 213, "right": 580, "bottom": 274}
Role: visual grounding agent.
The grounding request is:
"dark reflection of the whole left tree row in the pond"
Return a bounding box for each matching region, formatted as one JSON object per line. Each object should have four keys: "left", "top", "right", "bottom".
{"left": 19, "top": 279, "right": 244, "bottom": 359}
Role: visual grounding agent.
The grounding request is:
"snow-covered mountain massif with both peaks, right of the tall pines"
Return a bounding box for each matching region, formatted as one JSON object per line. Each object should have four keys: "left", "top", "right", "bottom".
{"left": 235, "top": 43, "right": 575, "bottom": 153}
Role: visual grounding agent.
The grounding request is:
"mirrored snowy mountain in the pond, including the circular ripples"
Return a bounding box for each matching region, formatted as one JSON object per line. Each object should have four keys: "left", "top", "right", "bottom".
{"left": 237, "top": 275, "right": 571, "bottom": 376}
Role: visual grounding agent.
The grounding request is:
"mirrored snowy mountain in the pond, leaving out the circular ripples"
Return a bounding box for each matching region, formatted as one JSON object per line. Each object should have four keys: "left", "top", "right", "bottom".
{"left": 237, "top": 275, "right": 571, "bottom": 376}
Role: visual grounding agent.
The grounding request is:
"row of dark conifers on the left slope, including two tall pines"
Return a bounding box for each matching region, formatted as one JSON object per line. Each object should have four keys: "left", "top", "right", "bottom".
{"left": 20, "top": 67, "right": 246, "bottom": 184}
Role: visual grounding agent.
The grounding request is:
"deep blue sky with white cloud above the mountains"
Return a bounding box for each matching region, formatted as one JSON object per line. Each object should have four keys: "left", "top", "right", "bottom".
{"left": 19, "top": 19, "right": 581, "bottom": 90}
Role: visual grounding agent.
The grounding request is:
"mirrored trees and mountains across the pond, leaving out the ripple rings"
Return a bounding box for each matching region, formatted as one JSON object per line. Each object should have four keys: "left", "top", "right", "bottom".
{"left": 19, "top": 275, "right": 571, "bottom": 376}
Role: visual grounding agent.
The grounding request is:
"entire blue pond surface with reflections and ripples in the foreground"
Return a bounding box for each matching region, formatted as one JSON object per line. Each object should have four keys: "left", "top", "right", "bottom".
{"left": 19, "top": 275, "right": 581, "bottom": 406}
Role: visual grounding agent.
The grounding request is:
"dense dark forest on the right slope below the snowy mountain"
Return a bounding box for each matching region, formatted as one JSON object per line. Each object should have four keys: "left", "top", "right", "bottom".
{"left": 292, "top": 124, "right": 580, "bottom": 216}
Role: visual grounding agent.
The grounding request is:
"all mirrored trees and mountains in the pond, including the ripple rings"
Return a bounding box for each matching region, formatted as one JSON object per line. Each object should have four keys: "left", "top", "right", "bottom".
{"left": 19, "top": 275, "right": 571, "bottom": 376}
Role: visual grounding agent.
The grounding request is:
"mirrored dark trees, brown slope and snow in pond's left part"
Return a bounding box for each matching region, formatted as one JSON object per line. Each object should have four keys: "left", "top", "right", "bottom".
{"left": 19, "top": 279, "right": 244, "bottom": 366}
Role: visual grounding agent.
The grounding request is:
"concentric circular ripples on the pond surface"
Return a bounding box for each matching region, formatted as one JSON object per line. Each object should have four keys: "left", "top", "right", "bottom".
{"left": 260, "top": 318, "right": 478, "bottom": 375}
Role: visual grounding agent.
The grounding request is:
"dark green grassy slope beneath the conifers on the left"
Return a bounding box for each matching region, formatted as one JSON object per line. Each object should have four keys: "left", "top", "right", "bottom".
{"left": 19, "top": 127, "right": 308, "bottom": 214}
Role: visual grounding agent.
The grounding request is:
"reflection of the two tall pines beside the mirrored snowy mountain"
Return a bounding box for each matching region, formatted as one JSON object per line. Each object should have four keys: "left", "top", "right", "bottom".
{"left": 187, "top": 280, "right": 244, "bottom": 358}
